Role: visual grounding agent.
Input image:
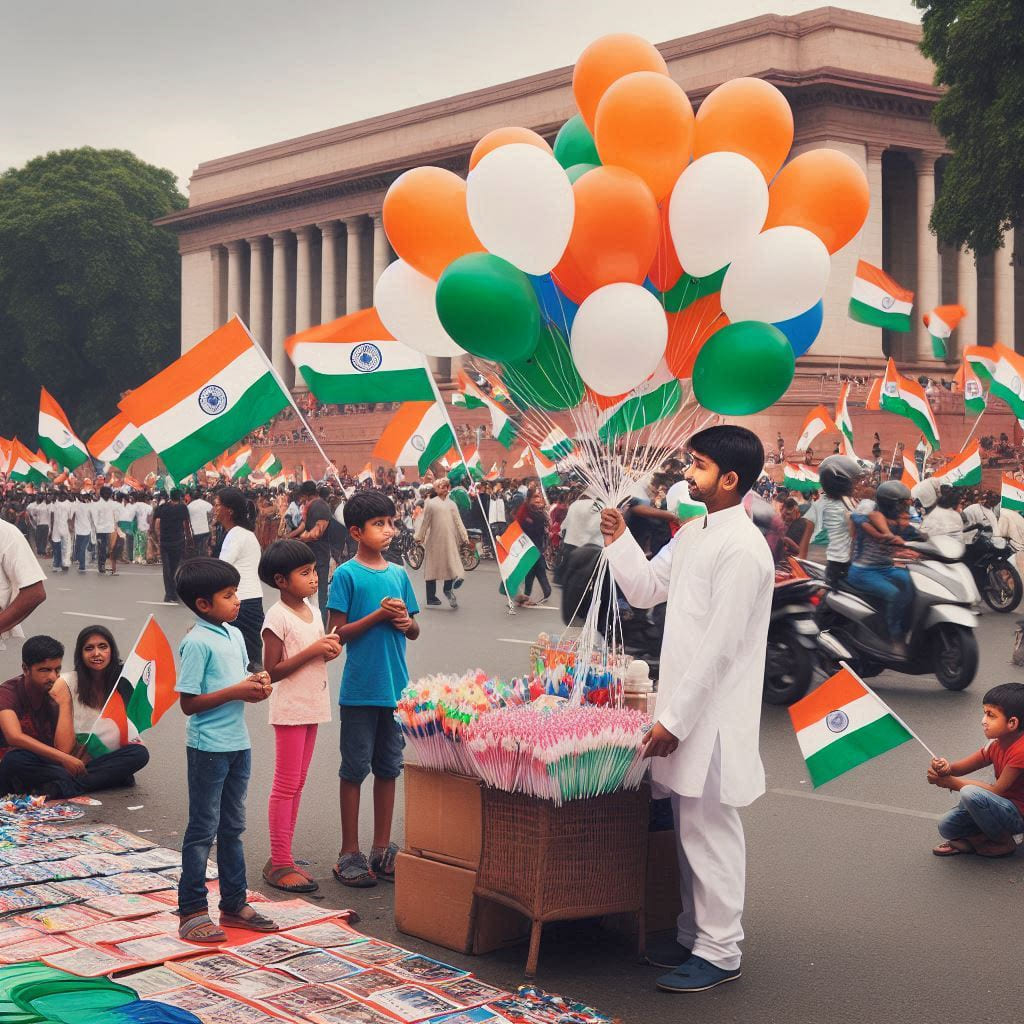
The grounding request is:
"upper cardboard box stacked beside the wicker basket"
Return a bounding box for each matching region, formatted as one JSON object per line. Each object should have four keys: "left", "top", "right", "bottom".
{"left": 406, "top": 765, "right": 481, "bottom": 871}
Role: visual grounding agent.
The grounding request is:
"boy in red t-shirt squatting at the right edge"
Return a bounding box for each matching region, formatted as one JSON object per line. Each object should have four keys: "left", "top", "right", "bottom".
{"left": 928, "top": 683, "right": 1024, "bottom": 857}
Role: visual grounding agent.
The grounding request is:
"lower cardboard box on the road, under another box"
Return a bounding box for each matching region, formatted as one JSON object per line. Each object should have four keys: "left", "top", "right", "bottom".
{"left": 394, "top": 853, "right": 529, "bottom": 954}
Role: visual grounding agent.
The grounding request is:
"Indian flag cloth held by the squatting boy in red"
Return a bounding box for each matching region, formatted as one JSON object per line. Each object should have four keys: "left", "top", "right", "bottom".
{"left": 790, "top": 669, "right": 913, "bottom": 788}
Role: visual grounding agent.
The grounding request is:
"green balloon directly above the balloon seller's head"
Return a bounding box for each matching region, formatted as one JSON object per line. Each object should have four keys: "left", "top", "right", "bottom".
{"left": 693, "top": 321, "right": 795, "bottom": 416}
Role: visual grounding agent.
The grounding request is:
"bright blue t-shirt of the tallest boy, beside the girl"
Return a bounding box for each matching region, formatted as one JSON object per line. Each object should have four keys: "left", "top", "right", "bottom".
{"left": 327, "top": 558, "right": 420, "bottom": 708}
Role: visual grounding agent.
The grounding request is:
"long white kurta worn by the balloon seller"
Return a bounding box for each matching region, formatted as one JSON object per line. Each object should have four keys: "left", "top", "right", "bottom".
{"left": 606, "top": 506, "right": 775, "bottom": 807}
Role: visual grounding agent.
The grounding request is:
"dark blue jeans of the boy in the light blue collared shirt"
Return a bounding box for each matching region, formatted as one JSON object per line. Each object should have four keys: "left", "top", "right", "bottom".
{"left": 178, "top": 746, "right": 252, "bottom": 914}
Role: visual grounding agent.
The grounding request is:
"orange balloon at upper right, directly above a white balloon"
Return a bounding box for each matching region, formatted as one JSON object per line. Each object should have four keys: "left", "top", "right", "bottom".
{"left": 693, "top": 78, "right": 793, "bottom": 181}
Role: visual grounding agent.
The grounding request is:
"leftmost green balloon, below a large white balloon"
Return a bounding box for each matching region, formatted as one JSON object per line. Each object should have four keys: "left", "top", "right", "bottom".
{"left": 434, "top": 253, "right": 541, "bottom": 362}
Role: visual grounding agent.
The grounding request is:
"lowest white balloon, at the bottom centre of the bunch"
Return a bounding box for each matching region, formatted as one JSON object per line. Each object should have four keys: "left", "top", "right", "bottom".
{"left": 569, "top": 283, "right": 669, "bottom": 395}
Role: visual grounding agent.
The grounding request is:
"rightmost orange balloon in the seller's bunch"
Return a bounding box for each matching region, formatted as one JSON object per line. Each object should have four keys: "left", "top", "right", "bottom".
{"left": 764, "top": 150, "right": 870, "bottom": 253}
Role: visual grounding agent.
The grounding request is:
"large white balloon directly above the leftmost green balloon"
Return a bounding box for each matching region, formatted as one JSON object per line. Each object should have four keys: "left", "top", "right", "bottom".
{"left": 466, "top": 142, "right": 575, "bottom": 274}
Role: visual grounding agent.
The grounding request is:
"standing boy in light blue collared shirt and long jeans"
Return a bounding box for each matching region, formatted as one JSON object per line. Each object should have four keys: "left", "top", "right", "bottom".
{"left": 174, "top": 558, "right": 278, "bottom": 943}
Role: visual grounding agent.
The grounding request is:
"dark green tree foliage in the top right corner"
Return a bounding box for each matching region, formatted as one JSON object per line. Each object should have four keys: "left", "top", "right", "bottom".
{"left": 914, "top": 0, "right": 1024, "bottom": 255}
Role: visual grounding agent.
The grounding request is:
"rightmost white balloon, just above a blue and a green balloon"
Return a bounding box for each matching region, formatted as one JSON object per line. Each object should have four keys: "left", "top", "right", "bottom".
{"left": 722, "top": 226, "right": 831, "bottom": 324}
